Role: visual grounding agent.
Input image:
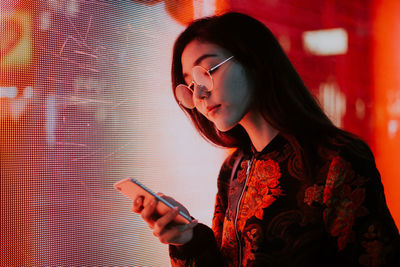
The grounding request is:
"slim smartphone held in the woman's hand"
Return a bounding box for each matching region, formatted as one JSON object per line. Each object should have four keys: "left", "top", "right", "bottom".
{"left": 114, "top": 178, "right": 192, "bottom": 224}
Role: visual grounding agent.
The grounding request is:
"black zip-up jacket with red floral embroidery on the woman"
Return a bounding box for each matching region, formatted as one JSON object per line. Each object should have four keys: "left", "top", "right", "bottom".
{"left": 169, "top": 135, "right": 400, "bottom": 267}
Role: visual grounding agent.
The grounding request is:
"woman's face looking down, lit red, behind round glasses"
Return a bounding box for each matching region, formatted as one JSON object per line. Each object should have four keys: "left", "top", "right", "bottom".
{"left": 181, "top": 40, "right": 254, "bottom": 132}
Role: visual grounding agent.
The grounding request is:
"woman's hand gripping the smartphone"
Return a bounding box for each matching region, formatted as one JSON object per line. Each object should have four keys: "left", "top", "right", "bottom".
{"left": 132, "top": 194, "right": 197, "bottom": 246}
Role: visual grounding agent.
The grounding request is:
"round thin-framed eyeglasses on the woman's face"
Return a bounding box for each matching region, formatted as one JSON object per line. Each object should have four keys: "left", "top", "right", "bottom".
{"left": 175, "top": 56, "right": 233, "bottom": 109}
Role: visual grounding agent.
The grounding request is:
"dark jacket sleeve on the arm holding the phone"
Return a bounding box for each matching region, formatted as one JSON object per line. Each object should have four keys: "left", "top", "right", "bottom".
{"left": 169, "top": 152, "right": 237, "bottom": 267}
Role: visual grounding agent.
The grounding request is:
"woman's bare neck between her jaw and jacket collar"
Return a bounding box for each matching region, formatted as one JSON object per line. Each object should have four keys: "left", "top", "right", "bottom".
{"left": 240, "top": 111, "right": 279, "bottom": 152}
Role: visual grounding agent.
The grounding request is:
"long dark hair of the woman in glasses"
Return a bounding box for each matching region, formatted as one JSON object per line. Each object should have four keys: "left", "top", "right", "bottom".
{"left": 172, "top": 12, "right": 370, "bottom": 175}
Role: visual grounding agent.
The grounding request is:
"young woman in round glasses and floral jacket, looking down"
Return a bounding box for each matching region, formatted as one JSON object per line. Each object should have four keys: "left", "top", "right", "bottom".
{"left": 133, "top": 13, "right": 400, "bottom": 266}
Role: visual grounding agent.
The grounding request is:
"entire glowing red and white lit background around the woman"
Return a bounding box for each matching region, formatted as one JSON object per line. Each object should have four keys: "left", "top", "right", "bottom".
{"left": 0, "top": 0, "right": 400, "bottom": 266}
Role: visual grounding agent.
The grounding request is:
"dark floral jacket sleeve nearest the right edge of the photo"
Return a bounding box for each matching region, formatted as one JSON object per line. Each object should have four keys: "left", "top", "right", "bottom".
{"left": 323, "top": 150, "right": 400, "bottom": 266}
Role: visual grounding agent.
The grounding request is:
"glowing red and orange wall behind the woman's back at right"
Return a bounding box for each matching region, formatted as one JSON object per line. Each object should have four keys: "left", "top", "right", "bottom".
{"left": 212, "top": 0, "right": 400, "bottom": 230}
